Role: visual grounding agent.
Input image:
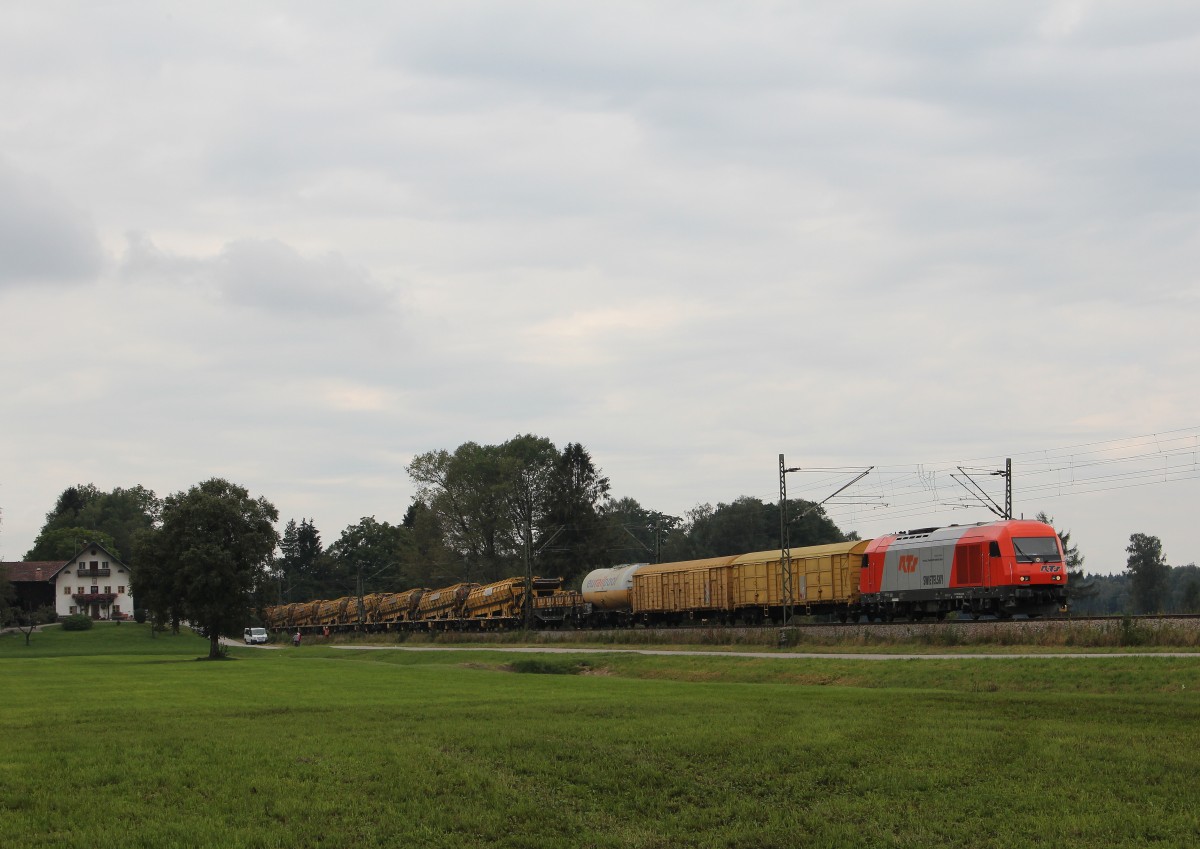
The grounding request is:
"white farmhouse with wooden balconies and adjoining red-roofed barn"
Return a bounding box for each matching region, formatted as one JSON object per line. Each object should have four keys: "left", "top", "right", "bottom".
{"left": 4, "top": 542, "right": 133, "bottom": 619}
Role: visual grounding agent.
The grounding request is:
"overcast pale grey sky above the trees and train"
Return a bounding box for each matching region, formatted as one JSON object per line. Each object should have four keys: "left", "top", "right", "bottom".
{"left": 0, "top": 0, "right": 1200, "bottom": 573}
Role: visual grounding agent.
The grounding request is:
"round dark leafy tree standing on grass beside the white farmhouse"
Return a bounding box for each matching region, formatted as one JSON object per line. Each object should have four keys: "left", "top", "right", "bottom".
{"left": 134, "top": 477, "right": 280, "bottom": 658}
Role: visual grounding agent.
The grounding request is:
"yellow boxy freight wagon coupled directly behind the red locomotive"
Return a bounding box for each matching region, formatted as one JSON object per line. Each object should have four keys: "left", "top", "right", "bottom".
{"left": 730, "top": 540, "right": 870, "bottom": 621}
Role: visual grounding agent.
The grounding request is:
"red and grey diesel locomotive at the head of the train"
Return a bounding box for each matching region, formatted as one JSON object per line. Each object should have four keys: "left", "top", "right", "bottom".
{"left": 860, "top": 519, "right": 1067, "bottom": 619}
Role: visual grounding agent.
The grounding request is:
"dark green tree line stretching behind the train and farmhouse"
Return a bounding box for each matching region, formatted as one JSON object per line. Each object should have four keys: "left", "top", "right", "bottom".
{"left": 9, "top": 434, "right": 1200, "bottom": 655}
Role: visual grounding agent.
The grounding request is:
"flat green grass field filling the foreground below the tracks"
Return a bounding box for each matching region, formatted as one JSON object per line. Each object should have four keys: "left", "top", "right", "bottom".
{"left": 0, "top": 624, "right": 1200, "bottom": 849}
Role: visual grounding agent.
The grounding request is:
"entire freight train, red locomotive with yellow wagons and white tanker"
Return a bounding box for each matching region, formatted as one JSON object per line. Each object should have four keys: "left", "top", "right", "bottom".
{"left": 263, "top": 519, "right": 1067, "bottom": 632}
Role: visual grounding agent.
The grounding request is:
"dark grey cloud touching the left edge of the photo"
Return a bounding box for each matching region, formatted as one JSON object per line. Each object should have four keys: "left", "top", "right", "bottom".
{"left": 0, "top": 162, "right": 104, "bottom": 287}
